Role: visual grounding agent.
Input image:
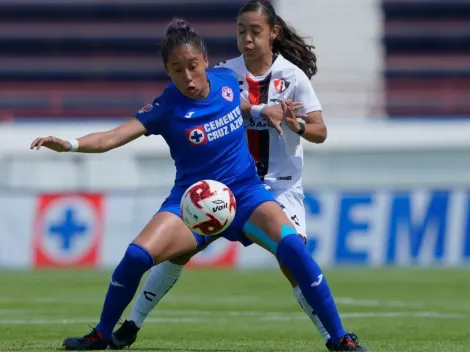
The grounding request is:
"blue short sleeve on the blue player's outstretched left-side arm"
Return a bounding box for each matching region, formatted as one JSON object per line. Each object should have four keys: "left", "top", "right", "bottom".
{"left": 134, "top": 92, "right": 170, "bottom": 136}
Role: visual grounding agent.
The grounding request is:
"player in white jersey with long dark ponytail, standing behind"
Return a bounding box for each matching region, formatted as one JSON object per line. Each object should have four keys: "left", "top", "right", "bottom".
{"left": 111, "top": 0, "right": 368, "bottom": 349}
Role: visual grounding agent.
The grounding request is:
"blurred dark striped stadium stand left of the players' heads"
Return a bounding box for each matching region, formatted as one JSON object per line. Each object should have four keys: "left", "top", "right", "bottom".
{"left": 0, "top": 0, "right": 242, "bottom": 120}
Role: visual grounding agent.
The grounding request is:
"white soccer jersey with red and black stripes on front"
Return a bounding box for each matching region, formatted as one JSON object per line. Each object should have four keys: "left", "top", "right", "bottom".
{"left": 217, "top": 55, "right": 321, "bottom": 190}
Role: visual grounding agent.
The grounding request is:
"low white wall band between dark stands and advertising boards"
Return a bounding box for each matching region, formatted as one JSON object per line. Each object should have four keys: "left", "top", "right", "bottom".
{"left": 0, "top": 120, "right": 470, "bottom": 191}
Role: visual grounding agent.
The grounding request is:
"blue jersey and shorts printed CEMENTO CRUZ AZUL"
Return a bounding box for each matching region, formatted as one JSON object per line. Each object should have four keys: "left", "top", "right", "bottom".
{"left": 135, "top": 68, "right": 275, "bottom": 245}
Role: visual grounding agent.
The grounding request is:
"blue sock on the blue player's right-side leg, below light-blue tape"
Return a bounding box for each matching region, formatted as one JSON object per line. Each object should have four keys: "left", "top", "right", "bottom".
{"left": 277, "top": 234, "right": 346, "bottom": 344}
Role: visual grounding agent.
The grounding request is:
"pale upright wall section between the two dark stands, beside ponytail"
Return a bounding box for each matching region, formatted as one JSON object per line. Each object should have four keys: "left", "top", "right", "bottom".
{"left": 275, "top": 0, "right": 384, "bottom": 119}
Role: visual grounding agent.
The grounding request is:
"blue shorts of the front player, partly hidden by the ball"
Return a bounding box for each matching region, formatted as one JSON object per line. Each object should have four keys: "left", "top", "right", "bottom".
{"left": 158, "top": 183, "right": 276, "bottom": 248}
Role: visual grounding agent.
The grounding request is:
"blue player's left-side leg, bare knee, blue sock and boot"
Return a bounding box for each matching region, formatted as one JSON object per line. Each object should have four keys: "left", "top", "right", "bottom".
{"left": 64, "top": 211, "right": 197, "bottom": 350}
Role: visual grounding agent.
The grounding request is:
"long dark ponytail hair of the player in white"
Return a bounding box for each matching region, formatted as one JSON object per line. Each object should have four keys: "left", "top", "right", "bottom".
{"left": 238, "top": 0, "right": 317, "bottom": 78}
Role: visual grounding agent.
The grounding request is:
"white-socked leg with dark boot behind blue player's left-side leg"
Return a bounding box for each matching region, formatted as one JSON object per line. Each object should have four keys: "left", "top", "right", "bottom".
{"left": 109, "top": 234, "right": 219, "bottom": 349}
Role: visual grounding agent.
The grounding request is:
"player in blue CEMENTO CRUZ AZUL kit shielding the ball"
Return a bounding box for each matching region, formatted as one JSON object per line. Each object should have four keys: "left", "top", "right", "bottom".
{"left": 31, "top": 20, "right": 367, "bottom": 351}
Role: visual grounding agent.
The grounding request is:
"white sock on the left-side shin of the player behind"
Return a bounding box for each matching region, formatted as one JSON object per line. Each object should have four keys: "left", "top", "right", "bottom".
{"left": 127, "top": 260, "right": 184, "bottom": 328}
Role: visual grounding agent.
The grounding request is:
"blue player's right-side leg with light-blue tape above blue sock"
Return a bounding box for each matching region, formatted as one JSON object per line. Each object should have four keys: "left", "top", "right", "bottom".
{"left": 244, "top": 191, "right": 368, "bottom": 351}
